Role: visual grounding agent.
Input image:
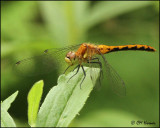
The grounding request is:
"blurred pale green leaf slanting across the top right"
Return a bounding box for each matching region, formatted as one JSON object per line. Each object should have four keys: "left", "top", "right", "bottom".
{"left": 86, "top": 1, "right": 152, "bottom": 29}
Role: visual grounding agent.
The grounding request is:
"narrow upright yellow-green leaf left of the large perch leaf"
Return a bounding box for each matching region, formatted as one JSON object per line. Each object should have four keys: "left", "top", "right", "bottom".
{"left": 28, "top": 80, "right": 44, "bottom": 127}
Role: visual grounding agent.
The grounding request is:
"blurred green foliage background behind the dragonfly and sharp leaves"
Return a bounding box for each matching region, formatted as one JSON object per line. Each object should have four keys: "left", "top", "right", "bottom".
{"left": 1, "top": 1, "right": 159, "bottom": 127}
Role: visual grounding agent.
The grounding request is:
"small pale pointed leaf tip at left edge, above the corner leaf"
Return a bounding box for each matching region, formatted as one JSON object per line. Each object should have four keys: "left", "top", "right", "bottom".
{"left": 1, "top": 91, "right": 18, "bottom": 111}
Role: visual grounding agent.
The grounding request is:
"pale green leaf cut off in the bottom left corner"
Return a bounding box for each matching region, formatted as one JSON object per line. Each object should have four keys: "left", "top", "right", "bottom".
{"left": 1, "top": 106, "right": 16, "bottom": 127}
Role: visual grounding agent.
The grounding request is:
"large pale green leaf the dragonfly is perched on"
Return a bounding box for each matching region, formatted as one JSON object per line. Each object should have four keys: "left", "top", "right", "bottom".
{"left": 36, "top": 67, "right": 100, "bottom": 127}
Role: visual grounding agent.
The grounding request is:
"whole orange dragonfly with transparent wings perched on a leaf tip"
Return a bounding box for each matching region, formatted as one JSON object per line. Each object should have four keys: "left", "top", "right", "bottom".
{"left": 15, "top": 43, "right": 156, "bottom": 96}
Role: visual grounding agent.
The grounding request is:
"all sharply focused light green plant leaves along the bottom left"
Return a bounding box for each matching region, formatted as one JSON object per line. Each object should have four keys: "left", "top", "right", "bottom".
{"left": 1, "top": 67, "right": 99, "bottom": 127}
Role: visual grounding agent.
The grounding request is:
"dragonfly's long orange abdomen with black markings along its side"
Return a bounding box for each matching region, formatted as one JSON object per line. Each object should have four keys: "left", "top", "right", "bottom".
{"left": 98, "top": 44, "right": 156, "bottom": 54}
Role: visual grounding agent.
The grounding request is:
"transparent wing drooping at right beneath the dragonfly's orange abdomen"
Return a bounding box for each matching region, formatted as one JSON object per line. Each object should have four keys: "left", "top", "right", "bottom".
{"left": 98, "top": 51, "right": 126, "bottom": 96}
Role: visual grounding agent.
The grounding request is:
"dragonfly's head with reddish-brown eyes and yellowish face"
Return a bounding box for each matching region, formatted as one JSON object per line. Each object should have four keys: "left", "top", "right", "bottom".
{"left": 65, "top": 51, "right": 77, "bottom": 65}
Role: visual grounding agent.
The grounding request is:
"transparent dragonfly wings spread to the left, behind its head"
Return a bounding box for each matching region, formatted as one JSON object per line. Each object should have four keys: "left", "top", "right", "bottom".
{"left": 13, "top": 44, "right": 80, "bottom": 76}
